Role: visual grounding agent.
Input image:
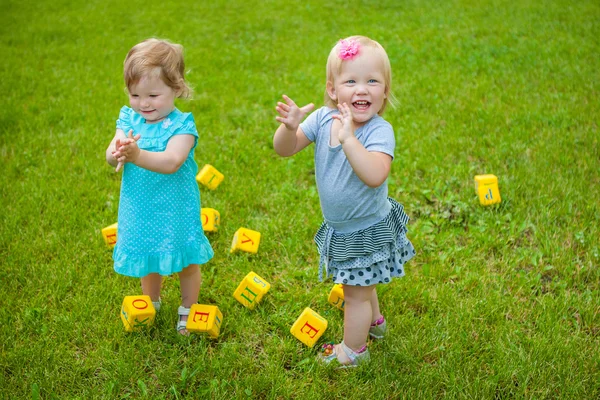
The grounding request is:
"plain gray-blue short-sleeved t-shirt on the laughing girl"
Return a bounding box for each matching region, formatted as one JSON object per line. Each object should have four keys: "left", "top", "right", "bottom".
{"left": 300, "top": 107, "right": 396, "bottom": 233}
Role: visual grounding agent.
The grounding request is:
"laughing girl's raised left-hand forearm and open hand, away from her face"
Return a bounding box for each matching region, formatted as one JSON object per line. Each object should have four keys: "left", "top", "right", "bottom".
{"left": 273, "top": 95, "right": 314, "bottom": 157}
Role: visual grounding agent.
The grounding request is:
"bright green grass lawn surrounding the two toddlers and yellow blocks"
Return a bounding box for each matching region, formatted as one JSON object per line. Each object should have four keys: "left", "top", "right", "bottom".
{"left": 0, "top": 0, "right": 600, "bottom": 399}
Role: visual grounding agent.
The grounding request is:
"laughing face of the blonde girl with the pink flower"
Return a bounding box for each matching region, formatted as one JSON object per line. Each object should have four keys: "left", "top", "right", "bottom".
{"left": 327, "top": 47, "right": 387, "bottom": 126}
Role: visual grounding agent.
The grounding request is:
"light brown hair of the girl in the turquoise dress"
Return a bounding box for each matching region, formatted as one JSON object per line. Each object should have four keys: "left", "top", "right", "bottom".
{"left": 123, "top": 38, "right": 192, "bottom": 99}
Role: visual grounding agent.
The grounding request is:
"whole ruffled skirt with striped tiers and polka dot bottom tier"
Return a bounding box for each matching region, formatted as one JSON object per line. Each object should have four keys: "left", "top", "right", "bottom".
{"left": 315, "top": 198, "right": 416, "bottom": 286}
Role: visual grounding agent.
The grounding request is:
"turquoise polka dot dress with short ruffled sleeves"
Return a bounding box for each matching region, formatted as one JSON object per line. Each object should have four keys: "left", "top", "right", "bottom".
{"left": 113, "top": 107, "right": 214, "bottom": 278}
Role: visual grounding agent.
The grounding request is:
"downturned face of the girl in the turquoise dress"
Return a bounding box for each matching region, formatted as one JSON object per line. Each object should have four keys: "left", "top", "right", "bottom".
{"left": 129, "top": 74, "right": 177, "bottom": 124}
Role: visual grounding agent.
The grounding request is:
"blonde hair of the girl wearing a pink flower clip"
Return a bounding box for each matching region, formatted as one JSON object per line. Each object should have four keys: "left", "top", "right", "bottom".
{"left": 325, "top": 36, "right": 396, "bottom": 115}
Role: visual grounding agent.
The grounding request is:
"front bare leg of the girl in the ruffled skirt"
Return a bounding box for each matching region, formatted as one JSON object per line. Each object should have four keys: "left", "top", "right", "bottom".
{"left": 336, "top": 285, "right": 375, "bottom": 363}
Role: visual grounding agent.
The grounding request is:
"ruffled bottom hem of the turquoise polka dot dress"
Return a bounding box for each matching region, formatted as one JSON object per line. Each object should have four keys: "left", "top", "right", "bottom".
{"left": 113, "top": 238, "right": 214, "bottom": 278}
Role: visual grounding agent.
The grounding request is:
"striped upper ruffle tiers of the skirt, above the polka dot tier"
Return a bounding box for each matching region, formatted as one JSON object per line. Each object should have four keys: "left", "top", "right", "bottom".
{"left": 315, "top": 198, "right": 410, "bottom": 262}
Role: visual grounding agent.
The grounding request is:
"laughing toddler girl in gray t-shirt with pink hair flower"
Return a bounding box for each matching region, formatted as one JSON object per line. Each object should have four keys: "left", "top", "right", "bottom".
{"left": 273, "top": 36, "right": 415, "bottom": 366}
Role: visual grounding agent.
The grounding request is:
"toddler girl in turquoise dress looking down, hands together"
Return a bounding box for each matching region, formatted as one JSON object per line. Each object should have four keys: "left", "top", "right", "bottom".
{"left": 106, "top": 39, "right": 213, "bottom": 335}
